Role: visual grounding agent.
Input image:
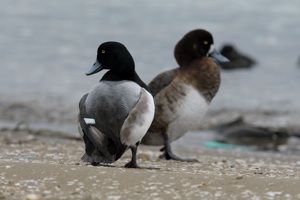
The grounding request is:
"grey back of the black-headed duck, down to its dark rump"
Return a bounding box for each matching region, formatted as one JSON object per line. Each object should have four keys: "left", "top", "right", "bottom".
{"left": 85, "top": 81, "right": 141, "bottom": 159}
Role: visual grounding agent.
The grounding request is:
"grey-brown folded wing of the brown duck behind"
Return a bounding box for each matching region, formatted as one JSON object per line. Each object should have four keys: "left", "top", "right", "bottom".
{"left": 148, "top": 69, "right": 176, "bottom": 96}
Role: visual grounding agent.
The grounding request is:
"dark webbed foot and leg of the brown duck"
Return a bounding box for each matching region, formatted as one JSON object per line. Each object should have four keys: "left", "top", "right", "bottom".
{"left": 159, "top": 133, "right": 199, "bottom": 162}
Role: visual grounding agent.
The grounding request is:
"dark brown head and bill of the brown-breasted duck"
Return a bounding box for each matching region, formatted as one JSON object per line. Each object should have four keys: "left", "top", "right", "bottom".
{"left": 174, "top": 29, "right": 228, "bottom": 66}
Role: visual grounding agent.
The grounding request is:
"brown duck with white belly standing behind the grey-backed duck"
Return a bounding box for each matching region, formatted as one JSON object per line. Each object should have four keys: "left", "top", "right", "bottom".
{"left": 142, "top": 29, "right": 228, "bottom": 161}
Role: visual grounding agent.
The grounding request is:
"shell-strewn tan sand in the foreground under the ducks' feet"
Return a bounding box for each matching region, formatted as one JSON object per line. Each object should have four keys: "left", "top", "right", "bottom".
{"left": 0, "top": 132, "right": 300, "bottom": 200}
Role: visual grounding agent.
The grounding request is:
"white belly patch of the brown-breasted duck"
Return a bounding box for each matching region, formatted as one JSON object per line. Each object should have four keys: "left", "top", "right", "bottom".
{"left": 167, "top": 85, "right": 209, "bottom": 141}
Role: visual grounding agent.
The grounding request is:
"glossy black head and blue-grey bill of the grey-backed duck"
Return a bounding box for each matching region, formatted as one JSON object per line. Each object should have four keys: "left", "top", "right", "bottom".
{"left": 86, "top": 42, "right": 135, "bottom": 75}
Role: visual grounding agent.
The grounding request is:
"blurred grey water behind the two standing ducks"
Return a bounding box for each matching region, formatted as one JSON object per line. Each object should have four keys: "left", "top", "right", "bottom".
{"left": 0, "top": 0, "right": 300, "bottom": 145}
